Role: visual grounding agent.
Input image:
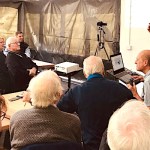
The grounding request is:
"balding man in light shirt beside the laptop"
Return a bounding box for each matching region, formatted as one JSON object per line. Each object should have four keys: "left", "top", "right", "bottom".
{"left": 128, "top": 50, "right": 150, "bottom": 108}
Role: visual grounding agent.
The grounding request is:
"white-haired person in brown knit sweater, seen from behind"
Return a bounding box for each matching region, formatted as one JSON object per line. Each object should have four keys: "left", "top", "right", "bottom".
{"left": 10, "top": 70, "right": 81, "bottom": 150}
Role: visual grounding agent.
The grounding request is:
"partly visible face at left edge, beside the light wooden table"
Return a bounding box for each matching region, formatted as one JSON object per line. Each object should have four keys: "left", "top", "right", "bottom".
{"left": 0, "top": 95, "right": 7, "bottom": 131}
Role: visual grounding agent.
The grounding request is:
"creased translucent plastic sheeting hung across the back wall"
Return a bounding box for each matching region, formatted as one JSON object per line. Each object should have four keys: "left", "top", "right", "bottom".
{"left": 0, "top": 0, "right": 120, "bottom": 59}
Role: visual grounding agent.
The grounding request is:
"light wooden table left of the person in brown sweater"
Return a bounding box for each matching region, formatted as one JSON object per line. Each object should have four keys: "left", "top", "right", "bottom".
{"left": 2, "top": 91, "right": 33, "bottom": 130}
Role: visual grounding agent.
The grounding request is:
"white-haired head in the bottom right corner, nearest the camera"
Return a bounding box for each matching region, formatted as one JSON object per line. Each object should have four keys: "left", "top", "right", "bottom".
{"left": 107, "top": 100, "right": 150, "bottom": 150}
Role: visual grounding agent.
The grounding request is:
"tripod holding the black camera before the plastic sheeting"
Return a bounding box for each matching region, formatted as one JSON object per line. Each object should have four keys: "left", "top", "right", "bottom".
{"left": 94, "top": 26, "right": 109, "bottom": 60}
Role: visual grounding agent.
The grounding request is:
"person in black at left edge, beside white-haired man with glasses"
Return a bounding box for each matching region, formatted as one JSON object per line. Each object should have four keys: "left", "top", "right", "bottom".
{"left": 0, "top": 37, "right": 12, "bottom": 94}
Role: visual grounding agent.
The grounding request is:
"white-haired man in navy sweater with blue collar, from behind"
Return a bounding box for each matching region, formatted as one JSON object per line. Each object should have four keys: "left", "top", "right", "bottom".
{"left": 57, "top": 56, "right": 132, "bottom": 150}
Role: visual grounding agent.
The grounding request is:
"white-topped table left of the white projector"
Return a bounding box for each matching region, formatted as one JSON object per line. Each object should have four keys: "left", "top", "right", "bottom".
{"left": 32, "top": 59, "right": 55, "bottom": 70}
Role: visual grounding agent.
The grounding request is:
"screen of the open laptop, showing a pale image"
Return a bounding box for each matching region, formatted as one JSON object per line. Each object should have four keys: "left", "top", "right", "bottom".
{"left": 110, "top": 53, "right": 125, "bottom": 74}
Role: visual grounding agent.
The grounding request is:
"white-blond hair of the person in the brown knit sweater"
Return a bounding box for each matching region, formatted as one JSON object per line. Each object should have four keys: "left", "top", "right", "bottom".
{"left": 28, "top": 70, "right": 63, "bottom": 107}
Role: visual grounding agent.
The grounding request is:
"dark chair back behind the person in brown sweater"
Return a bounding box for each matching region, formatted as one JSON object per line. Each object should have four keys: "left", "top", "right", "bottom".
{"left": 21, "top": 141, "right": 83, "bottom": 150}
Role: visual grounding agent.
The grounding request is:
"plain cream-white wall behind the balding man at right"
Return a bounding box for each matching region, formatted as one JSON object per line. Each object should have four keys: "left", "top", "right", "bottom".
{"left": 120, "top": 0, "right": 150, "bottom": 71}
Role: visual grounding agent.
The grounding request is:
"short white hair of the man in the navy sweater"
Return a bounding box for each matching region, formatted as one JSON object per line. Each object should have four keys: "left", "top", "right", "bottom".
{"left": 83, "top": 56, "right": 104, "bottom": 77}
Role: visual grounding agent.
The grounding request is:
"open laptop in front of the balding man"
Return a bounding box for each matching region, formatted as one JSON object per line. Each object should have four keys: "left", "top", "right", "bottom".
{"left": 110, "top": 53, "right": 132, "bottom": 84}
